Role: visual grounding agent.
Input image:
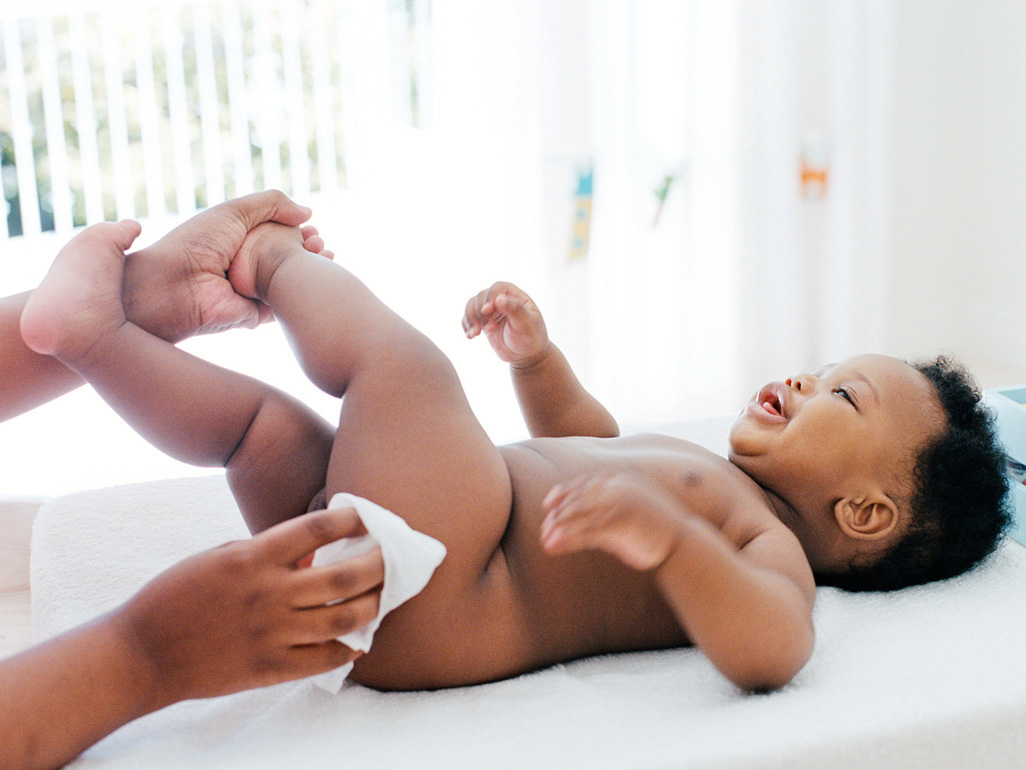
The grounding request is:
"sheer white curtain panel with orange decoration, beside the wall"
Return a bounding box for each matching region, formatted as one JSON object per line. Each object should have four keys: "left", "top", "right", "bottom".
{"left": 739, "top": 0, "right": 891, "bottom": 381}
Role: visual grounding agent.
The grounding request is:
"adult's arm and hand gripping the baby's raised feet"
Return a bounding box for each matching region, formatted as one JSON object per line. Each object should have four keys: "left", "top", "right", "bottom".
{"left": 0, "top": 190, "right": 310, "bottom": 421}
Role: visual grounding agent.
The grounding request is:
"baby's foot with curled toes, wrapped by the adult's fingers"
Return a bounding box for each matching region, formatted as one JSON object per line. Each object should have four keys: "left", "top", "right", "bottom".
{"left": 228, "top": 222, "right": 334, "bottom": 300}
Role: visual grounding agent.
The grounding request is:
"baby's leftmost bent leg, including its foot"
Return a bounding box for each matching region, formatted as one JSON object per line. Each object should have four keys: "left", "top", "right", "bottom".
{"left": 22, "top": 222, "right": 333, "bottom": 530}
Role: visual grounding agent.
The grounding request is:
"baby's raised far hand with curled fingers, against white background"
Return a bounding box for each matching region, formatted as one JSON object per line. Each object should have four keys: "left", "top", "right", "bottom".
{"left": 463, "top": 281, "right": 549, "bottom": 368}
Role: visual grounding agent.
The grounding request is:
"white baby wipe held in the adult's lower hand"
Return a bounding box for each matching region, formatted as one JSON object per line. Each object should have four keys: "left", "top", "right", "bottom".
{"left": 312, "top": 492, "right": 445, "bottom": 694}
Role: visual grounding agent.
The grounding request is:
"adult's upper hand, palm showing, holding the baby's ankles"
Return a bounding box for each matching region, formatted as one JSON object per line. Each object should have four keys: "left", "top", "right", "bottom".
{"left": 123, "top": 190, "right": 322, "bottom": 343}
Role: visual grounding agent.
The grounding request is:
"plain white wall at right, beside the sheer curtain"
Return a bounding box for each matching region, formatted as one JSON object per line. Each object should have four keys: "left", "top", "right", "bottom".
{"left": 886, "top": 0, "right": 1026, "bottom": 387}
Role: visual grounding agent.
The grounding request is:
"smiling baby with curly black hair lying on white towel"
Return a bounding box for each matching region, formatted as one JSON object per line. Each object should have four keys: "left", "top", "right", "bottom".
{"left": 22, "top": 222, "right": 1007, "bottom": 690}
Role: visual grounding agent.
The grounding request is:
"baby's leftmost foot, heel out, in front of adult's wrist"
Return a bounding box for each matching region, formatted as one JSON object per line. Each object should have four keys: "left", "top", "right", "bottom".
{"left": 22, "top": 220, "right": 142, "bottom": 365}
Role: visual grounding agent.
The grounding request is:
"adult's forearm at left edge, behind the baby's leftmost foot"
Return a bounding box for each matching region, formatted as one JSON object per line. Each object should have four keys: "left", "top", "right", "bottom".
{"left": 0, "top": 292, "right": 82, "bottom": 421}
